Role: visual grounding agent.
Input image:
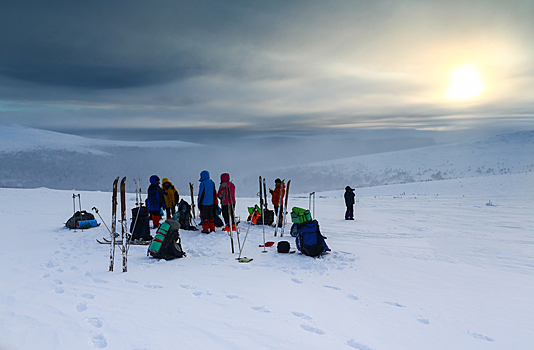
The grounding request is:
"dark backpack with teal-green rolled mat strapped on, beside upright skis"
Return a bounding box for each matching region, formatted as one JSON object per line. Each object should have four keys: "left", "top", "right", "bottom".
{"left": 148, "top": 219, "right": 185, "bottom": 260}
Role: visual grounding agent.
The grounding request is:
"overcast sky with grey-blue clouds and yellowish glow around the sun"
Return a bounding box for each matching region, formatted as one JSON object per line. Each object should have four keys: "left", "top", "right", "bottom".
{"left": 0, "top": 0, "right": 534, "bottom": 141}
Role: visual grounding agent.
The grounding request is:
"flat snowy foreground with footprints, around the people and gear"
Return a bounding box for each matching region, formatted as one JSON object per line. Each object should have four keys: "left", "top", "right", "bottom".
{"left": 0, "top": 172, "right": 534, "bottom": 350}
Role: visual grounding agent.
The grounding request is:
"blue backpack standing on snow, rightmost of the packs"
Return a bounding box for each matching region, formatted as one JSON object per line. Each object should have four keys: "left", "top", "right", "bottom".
{"left": 291, "top": 220, "right": 330, "bottom": 257}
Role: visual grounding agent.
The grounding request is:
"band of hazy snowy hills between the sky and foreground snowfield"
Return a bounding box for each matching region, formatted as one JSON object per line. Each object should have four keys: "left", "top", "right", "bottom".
{"left": 0, "top": 124, "right": 534, "bottom": 196}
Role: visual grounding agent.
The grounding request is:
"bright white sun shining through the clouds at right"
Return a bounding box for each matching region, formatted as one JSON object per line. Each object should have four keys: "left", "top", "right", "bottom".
{"left": 446, "top": 66, "right": 484, "bottom": 100}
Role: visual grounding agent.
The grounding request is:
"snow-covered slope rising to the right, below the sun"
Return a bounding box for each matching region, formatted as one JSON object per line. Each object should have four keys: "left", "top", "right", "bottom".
{"left": 242, "top": 131, "right": 534, "bottom": 193}
